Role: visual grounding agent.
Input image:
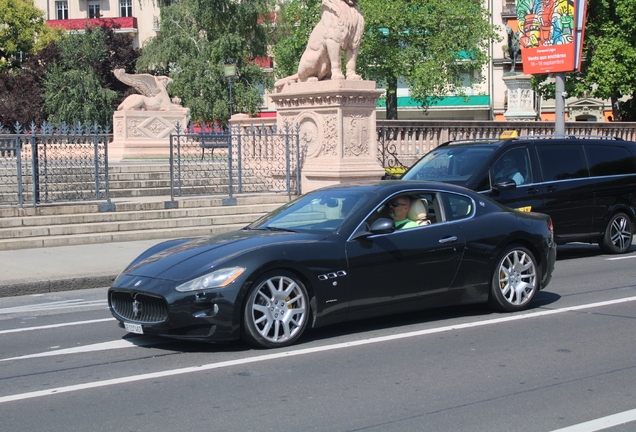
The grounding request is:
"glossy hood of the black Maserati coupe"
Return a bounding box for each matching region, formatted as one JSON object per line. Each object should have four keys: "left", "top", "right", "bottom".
{"left": 124, "top": 230, "right": 325, "bottom": 281}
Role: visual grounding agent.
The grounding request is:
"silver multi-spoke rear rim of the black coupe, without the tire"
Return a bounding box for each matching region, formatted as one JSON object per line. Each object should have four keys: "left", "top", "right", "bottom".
{"left": 498, "top": 249, "right": 537, "bottom": 308}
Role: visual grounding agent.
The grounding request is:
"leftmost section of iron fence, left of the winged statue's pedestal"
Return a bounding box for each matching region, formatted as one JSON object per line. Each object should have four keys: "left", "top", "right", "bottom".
{"left": 0, "top": 123, "right": 112, "bottom": 205}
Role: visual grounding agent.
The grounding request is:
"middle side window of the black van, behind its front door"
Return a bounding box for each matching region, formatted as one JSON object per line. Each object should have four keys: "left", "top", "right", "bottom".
{"left": 537, "top": 144, "right": 589, "bottom": 181}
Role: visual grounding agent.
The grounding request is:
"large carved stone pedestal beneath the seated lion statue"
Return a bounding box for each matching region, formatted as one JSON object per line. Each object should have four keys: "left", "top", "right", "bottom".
{"left": 271, "top": 80, "right": 384, "bottom": 193}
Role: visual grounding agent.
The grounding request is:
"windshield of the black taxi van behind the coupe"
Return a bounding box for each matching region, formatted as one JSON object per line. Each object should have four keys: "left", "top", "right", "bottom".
{"left": 402, "top": 146, "right": 494, "bottom": 185}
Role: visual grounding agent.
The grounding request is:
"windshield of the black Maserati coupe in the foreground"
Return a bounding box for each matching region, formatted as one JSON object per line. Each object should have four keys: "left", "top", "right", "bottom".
{"left": 247, "top": 190, "right": 370, "bottom": 232}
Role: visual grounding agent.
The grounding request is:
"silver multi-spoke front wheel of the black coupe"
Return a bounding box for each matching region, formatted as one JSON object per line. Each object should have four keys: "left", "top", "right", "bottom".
{"left": 248, "top": 275, "right": 308, "bottom": 346}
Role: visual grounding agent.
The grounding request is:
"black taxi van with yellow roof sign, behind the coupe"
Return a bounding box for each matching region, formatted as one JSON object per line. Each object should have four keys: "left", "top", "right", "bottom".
{"left": 402, "top": 135, "right": 636, "bottom": 253}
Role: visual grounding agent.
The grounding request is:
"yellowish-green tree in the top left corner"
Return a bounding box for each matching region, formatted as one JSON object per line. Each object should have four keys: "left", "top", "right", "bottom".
{"left": 0, "top": 0, "right": 59, "bottom": 73}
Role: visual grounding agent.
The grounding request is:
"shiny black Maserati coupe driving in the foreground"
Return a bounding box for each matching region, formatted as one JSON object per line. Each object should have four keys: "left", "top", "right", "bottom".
{"left": 108, "top": 181, "right": 556, "bottom": 348}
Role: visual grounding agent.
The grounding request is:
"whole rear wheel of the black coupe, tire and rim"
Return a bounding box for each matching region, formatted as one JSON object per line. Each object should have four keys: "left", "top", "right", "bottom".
{"left": 488, "top": 245, "right": 541, "bottom": 312}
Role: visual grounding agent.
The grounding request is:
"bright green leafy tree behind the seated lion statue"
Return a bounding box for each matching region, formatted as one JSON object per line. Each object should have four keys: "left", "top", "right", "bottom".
{"left": 275, "top": 0, "right": 499, "bottom": 119}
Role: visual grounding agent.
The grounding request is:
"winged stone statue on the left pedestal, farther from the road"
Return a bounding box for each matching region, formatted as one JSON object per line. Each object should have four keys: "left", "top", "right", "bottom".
{"left": 113, "top": 69, "right": 188, "bottom": 111}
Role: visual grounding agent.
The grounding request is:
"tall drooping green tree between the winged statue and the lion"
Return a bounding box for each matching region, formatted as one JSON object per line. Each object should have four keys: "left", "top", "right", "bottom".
{"left": 137, "top": 0, "right": 271, "bottom": 124}
